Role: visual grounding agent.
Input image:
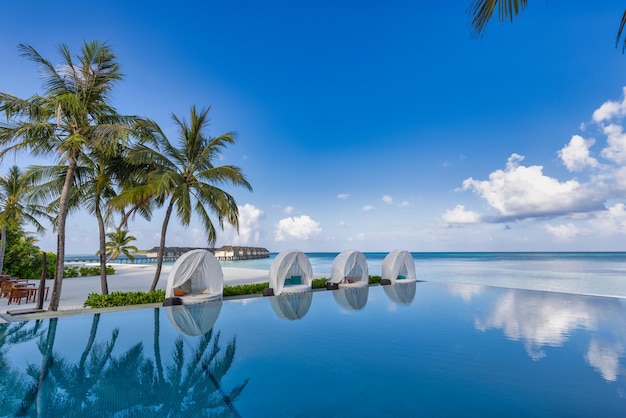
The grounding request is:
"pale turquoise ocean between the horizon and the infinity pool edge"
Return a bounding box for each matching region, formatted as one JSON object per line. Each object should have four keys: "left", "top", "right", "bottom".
{"left": 66, "top": 252, "right": 626, "bottom": 298}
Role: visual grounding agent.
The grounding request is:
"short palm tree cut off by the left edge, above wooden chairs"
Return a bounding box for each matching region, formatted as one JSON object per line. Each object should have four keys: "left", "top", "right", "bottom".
{"left": 0, "top": 166, "right": 50, "bottom": 272}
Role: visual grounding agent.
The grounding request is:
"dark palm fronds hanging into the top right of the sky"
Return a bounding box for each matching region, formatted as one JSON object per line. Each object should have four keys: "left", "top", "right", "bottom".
{"left": 467, "top": 0, "right": 626, "bottom": 53}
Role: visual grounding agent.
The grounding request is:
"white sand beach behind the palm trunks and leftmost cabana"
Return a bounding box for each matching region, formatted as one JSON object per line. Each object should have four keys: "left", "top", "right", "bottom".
{"left": 0, "top": 263, "right": 269, "bottom": 314}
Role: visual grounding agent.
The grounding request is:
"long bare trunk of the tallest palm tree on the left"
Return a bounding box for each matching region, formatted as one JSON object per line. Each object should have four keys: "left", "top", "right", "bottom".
{"left": 49, "top": 151, "right": 78, "bottom": 311}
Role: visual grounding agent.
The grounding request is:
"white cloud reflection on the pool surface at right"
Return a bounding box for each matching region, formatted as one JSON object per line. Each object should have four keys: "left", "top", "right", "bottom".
{"left": 449, "top": 285, "right": 626, "bottom": 382}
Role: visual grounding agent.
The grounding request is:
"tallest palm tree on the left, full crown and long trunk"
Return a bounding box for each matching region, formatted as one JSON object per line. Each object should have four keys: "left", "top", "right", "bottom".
{"left": 0, "top": 41, "right": 143, "bottom": 311}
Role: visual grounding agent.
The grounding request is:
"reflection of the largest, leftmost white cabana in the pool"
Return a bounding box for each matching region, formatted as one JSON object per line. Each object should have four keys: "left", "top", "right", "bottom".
{"left": 164, "top": 300, "right": 222, "bottom": 336}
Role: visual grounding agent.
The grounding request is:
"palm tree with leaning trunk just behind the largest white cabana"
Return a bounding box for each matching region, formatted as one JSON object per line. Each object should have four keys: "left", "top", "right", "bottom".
{"left": 114, "top": 106, "right": 252, "bottom": 291}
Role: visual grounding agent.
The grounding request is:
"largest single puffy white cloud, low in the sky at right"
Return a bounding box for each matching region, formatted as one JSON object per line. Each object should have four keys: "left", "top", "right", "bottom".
{"left": 463, "top": 154, "right": 600, "bottom": 218}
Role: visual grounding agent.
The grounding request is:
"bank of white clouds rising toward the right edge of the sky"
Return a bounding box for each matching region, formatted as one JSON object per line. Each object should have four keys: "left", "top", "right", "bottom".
{"left": 441, "top": 87, "right": 626, "bottom": 242}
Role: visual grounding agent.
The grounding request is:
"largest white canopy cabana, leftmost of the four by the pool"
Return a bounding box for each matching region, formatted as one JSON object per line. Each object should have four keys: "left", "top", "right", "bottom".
{"left": 165, "top": 250, "right": 224, "bottom": 303}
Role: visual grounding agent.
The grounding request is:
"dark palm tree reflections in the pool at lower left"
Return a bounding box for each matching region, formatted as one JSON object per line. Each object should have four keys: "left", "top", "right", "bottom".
{"left": 0, "top": 309, "right": 248, "bottom": 417}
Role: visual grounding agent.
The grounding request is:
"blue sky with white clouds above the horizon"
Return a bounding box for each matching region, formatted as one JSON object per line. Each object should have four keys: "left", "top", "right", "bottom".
{"left": 0, "top": 0, "right": 626, "bottom": 254}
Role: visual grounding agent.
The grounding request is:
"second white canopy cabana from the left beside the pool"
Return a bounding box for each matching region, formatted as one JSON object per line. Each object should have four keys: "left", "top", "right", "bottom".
{"left": 269, "top": 250, "right": 313, "bottom": 295}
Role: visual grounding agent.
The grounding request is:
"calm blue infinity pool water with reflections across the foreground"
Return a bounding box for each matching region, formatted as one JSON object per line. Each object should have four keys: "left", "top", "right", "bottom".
{"left": 0, "top": 282, "right": 626, "bottom": 417}
